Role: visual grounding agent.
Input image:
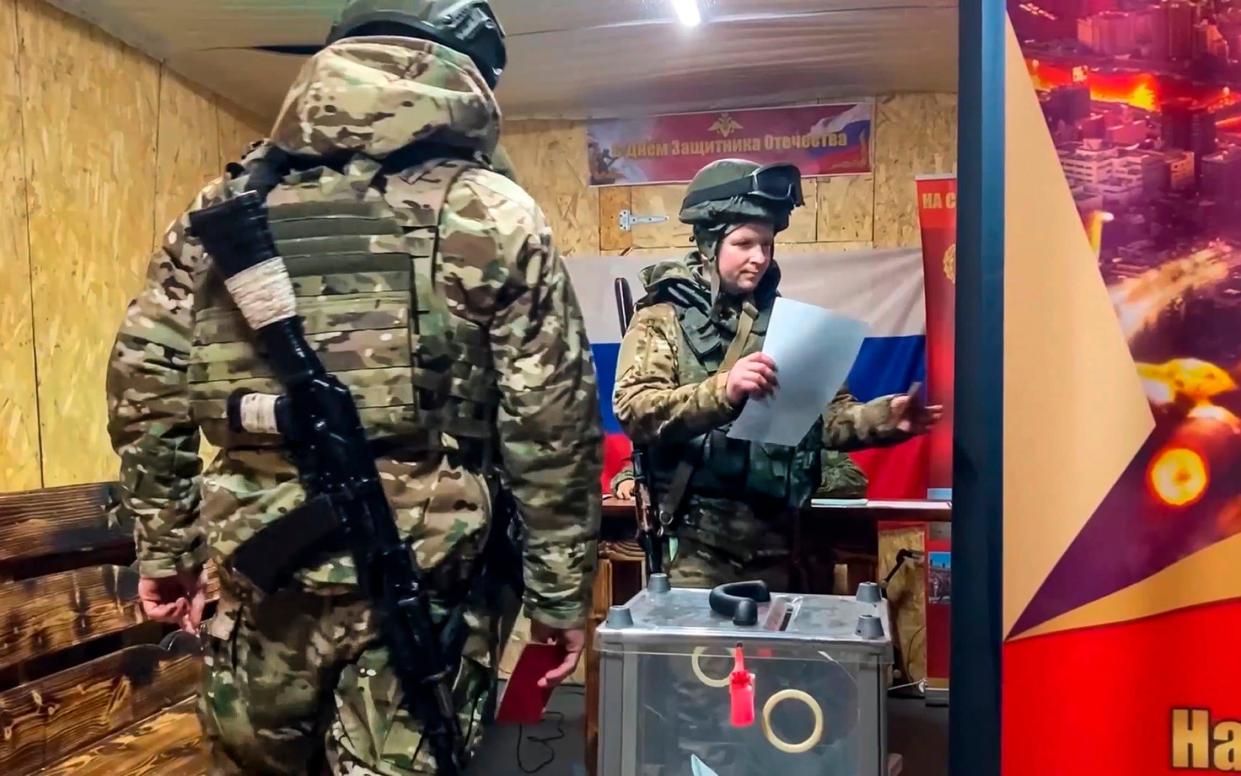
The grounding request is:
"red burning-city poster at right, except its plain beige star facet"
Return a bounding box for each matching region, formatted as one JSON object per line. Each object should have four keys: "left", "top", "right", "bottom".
{"left": 1004, "top": 0, "right": 1241, "bottom": 776}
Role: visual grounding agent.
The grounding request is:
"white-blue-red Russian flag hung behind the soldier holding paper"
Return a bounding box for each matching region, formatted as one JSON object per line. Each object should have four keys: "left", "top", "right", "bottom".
{"left": 565, "top": 248, "right": 928, "bottom": 499}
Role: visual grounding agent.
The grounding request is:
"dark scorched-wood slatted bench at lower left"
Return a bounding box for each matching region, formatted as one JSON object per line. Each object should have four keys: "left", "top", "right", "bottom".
{"left": 0, "top": 484, "right": 216, "bottom": 776}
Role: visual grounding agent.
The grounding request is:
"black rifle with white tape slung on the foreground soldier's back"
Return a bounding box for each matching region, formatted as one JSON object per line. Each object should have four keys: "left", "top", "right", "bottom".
{"left": 190, "top": 191, "right": 467, "bottom": 776}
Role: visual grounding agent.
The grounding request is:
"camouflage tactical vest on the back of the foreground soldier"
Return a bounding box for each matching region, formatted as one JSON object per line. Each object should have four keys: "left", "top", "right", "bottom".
{"left": 189, "top": 156, "right": 499, "bottom": 463}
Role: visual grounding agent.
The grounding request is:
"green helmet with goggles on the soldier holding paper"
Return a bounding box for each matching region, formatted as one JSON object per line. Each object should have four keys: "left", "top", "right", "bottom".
{"left": 680, "top": 159, "right": 804, "bottom": 232}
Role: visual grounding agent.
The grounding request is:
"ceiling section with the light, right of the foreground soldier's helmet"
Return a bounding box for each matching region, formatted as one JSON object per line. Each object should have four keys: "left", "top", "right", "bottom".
{"left": 500, "top": 9, "right": 957, "bottom": 115}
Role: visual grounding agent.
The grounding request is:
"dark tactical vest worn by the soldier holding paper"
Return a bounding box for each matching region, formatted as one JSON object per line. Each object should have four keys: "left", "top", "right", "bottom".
{"left": 650, "top": 297, "right": 823, "bottom": 509}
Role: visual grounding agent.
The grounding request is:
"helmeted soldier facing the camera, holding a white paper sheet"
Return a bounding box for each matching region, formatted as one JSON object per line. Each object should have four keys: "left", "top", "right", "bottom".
{"left": 613, "top": 159, "right": 941, "bottom": 590}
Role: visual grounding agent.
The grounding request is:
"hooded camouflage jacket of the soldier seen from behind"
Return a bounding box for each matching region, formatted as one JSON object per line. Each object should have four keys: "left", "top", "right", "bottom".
{"left": 108, "top": 40, "right": 602, "bottom": 627}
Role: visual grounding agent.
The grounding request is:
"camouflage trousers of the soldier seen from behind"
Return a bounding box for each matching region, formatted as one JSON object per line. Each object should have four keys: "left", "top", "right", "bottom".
{"left": 199, "top": 571, "right": 496, "bottom": 776}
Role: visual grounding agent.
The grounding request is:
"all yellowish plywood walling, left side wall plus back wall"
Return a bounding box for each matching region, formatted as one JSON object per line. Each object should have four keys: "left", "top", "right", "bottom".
{"left": 0, "top": 0, "right": 956, "bottom": 492}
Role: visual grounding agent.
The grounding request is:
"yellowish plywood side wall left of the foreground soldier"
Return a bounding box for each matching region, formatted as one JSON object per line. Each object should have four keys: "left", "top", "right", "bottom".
{"left": 0, "top": 0, "right": 264, "bottom": 492}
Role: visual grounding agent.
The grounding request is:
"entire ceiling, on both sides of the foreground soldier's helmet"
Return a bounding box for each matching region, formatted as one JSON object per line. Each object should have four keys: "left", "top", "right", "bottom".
{"left": 41, "top": 0, "right": 957, "bottom": 118}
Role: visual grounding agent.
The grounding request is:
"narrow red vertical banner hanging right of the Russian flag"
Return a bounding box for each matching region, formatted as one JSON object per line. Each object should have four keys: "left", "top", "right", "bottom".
{"left": 917, "top": 175, "right": 957, "bottom": 500}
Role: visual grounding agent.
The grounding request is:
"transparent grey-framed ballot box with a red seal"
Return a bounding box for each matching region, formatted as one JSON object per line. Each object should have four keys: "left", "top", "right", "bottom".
{"left": 594, "top": 575, "right": 892, "bottom": 776}
